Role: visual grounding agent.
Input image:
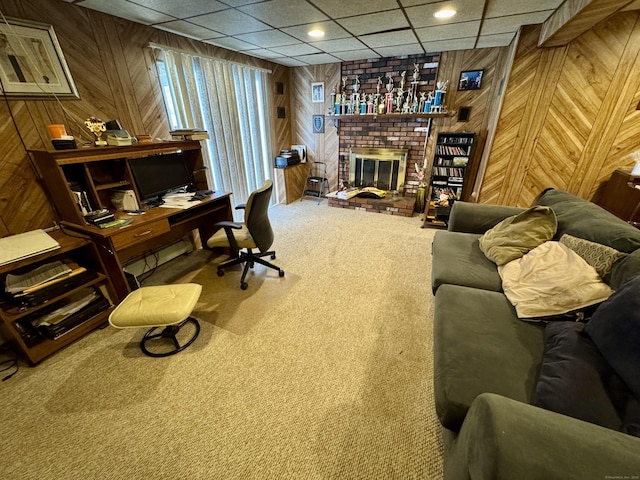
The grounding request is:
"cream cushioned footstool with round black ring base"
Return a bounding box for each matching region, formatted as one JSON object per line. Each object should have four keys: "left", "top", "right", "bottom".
{"left": 109, "top": 283, "right": 202, "bottom": 357}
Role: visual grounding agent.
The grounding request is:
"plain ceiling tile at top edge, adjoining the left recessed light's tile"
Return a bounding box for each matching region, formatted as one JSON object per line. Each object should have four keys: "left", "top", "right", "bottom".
{"left": 239, "top": 0, "right": 328, "bottom": 28}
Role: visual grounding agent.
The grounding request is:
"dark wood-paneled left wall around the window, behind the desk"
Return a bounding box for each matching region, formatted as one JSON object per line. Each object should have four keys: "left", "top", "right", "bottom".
{"left": 0, "top": 0, "right": 291, "bottom": 236}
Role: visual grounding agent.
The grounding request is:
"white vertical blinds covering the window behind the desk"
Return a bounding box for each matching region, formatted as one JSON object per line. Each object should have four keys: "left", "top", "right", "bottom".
{"left": 153, "top": 46, "right": 271, "bottom": 210}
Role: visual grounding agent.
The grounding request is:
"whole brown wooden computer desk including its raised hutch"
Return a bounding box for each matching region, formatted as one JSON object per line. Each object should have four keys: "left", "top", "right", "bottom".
{"left": 30, "top": 140, "right": 233, "bottom": 301}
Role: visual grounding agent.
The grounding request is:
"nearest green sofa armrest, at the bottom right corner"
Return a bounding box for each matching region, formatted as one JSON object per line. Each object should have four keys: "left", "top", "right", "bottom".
{"left": 445, "top": 393, "right": 640, "bottom": 480}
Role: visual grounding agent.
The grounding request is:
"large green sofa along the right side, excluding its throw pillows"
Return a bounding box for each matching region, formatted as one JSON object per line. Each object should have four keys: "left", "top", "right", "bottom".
{"left": 432, "top": 189, "right": 640, "bottom": 480}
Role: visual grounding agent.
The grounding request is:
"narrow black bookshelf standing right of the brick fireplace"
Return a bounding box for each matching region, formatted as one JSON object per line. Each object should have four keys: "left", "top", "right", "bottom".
{"left": 424, "top": 132, "right": 476, "bottom": 225}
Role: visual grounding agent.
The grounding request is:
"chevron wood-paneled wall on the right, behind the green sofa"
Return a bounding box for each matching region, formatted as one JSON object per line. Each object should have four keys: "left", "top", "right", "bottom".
{"left": 479, "top": 12, "right": 640, "bottom": 206}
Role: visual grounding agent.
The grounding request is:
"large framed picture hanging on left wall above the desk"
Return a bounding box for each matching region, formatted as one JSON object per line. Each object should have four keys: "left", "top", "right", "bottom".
{"left": 0, "top": 18, "right": 78, "bottom": 98}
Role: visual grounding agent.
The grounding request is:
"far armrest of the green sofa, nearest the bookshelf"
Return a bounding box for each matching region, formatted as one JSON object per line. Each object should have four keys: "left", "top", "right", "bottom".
{"left": 448, "top": 201, "right": 525, "bottom": 234}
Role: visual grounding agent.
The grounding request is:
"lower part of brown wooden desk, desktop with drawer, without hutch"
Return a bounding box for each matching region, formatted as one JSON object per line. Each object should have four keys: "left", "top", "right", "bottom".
{"left": 62, "top": 192, "right": 233, "bottom": 300}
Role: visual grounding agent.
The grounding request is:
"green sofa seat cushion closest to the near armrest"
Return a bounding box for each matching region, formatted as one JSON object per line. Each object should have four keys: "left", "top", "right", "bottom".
{"left": 433, "top": 285, "right": 544, "bottom": 430}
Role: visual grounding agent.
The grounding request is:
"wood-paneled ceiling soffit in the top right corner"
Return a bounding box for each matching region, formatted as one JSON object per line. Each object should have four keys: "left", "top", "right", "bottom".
{"left": 538, "top": 0, "right": 633, "bottom": 47}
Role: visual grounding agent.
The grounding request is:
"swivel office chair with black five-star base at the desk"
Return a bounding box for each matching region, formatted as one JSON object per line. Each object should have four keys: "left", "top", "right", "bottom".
{"left": 207, "top": 180, "right": 284, "bottom": 290}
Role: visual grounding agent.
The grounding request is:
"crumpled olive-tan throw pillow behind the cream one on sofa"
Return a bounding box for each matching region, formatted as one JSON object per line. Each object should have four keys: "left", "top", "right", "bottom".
{"left": 480, "top": 206, "right": 558, "bottom": 265}
